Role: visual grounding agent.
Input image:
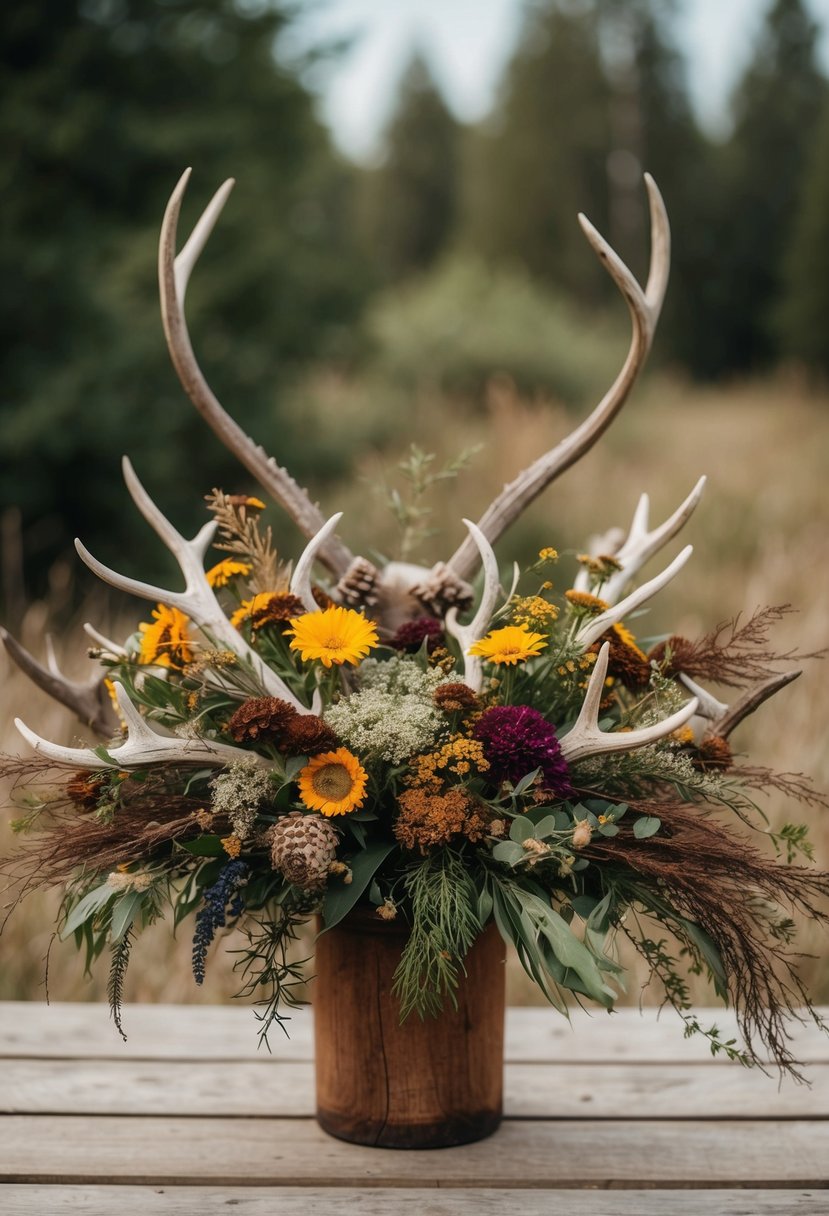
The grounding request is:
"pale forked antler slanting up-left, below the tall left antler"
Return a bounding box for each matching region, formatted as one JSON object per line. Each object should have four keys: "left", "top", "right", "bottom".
{"left": 75, "top": 457, "right": 316, "bottom": 714}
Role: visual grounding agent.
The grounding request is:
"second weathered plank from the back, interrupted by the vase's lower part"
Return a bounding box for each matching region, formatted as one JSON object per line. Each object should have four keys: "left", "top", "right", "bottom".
{"left": 0, "top": 1059, "right": 829, "bottom": 1113}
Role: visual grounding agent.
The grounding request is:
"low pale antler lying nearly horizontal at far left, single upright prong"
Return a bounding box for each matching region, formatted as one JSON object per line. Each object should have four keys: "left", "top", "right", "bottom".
{"left": 15, "top": 681, "right": 261, "bottom": 769}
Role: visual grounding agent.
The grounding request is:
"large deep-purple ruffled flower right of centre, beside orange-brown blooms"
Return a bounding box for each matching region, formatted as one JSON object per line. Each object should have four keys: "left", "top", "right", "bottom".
{"left": 475, "top": 705, "right": 573, "bottom": 798}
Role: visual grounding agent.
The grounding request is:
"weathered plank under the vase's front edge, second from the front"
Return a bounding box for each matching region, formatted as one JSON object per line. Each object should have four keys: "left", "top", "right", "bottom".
{"left": 0, "top": 1115, "right": 829, "bottom": 1189}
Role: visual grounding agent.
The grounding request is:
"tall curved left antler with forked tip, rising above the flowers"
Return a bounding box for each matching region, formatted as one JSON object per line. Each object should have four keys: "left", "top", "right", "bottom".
{"left": 158, "top": 169, "right": 353, "bottom": 578}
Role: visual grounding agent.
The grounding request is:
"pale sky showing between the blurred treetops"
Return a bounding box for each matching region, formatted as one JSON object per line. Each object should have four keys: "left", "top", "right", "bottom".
{"left": 284, "top": 0, "right": 829, "bottom": 163}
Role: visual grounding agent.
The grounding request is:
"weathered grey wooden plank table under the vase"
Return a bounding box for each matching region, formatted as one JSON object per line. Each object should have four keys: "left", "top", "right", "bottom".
{"left": 0, "top": 1002, "right": 829, "bottom": 1216}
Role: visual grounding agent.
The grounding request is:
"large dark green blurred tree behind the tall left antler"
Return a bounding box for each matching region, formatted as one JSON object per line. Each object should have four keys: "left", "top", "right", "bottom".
{"left": 0, "top": 0, "right": 361, "bottom": 588}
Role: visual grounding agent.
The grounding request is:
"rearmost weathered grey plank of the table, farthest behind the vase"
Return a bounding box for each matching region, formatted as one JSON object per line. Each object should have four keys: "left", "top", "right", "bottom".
{"left": 0, "top": 1001, "right": 829, "bottom": 1064}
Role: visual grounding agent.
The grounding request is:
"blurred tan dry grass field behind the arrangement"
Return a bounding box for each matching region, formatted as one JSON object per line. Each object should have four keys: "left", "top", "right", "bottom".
{"left": 0, "top": 377, "right": 829, "bottom": 1032}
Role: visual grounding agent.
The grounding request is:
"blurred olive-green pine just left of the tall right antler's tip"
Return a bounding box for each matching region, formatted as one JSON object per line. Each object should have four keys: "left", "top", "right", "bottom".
{"left": 464, "top": 0, "right": 609, "bottom": 300}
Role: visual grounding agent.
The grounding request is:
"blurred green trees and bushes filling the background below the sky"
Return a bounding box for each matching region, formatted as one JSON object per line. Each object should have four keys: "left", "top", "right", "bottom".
{"left": 0, "top": 0, "right": 829, "bottom": 605}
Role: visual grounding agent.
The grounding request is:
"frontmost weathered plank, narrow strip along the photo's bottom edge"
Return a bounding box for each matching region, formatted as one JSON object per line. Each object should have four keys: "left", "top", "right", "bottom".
{"left": 0, "top": 1186, "right": 829, "bottom": 1216}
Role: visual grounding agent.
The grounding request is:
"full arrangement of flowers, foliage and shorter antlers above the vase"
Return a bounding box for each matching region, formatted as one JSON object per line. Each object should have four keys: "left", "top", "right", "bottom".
{"left": 5, "top": 164, "right": 829, "bottom": 1070}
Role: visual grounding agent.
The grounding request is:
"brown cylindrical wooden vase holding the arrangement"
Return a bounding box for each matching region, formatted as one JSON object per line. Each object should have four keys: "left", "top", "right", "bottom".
{"left": 314, "top": 910, "right": 504, "bottom": 1148}
